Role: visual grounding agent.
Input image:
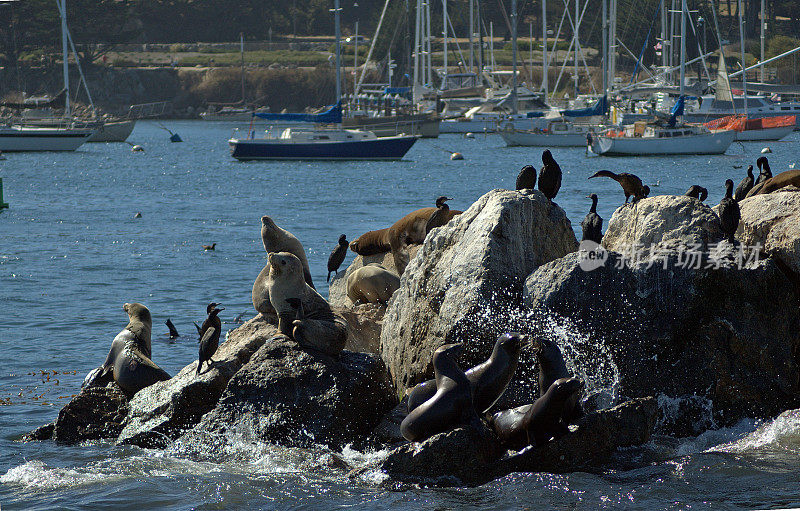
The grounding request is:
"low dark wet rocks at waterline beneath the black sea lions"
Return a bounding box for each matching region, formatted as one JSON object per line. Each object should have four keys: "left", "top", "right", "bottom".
{"left": 381, "top": 397, "right": 658, "bottom": 486}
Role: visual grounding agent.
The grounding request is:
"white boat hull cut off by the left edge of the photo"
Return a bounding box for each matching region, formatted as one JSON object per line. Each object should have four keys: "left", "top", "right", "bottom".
{"left": 0, "top": 126, "right": 94, "bottom": 152}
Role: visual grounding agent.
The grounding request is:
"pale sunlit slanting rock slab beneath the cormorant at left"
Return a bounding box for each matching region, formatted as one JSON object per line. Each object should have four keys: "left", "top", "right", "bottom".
{"left": 117, "top": 315, "right": 277, "bottom": 448}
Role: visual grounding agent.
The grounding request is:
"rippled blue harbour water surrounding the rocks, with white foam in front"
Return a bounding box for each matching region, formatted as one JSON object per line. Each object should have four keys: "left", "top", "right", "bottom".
{"left": 0, "top": 121, "right": 800, "bottom": 511}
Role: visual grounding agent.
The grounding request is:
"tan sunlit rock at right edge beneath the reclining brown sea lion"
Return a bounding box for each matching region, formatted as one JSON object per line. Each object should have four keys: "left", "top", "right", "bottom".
{"left": 736, "top": 189, "right": 800, "bottom": 276}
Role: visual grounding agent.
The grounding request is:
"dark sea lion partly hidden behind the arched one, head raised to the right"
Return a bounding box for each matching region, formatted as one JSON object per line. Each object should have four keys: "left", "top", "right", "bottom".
{"left": 408, "top": 332, "right": 525, "bottom": 413}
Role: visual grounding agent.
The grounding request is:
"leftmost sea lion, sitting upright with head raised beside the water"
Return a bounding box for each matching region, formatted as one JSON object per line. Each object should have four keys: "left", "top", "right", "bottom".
{"left": 84, "top": 303, "right": 170, "bottom": 397}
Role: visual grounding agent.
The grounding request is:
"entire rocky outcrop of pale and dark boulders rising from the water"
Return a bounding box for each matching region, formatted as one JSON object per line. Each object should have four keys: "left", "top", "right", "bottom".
{"left": 21, "top": 189, "right": 800, "bottom": 485}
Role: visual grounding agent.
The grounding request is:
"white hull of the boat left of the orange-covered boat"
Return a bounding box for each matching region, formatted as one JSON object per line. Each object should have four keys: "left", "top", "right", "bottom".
{"left": 592, "top": 131, "right": 736, "bottom": 156}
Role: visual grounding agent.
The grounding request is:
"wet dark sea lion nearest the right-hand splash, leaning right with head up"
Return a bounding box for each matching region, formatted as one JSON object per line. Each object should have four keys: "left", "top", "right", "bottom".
{"left": 490, "top": 378, "right": 583, "bottom": 449}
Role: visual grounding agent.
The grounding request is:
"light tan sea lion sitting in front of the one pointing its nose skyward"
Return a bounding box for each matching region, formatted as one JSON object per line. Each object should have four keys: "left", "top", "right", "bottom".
{"left": 267, "top": 252, "right": 347, "bottom": 356}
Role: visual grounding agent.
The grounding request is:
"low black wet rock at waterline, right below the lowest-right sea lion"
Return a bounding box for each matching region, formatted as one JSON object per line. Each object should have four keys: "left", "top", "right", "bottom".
{"left": 496, "top": 397, "right": 658, "bottom": 478}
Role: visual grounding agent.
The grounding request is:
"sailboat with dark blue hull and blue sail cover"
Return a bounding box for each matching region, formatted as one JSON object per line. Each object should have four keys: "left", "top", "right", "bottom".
{"left": 228, "top": 0, "right": 418, "bottom": 160}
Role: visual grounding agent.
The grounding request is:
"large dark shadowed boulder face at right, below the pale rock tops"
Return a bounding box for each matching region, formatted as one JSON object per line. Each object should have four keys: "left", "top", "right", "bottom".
{"left": 525, "top": 250, "right": 800, "bottom": 430}
